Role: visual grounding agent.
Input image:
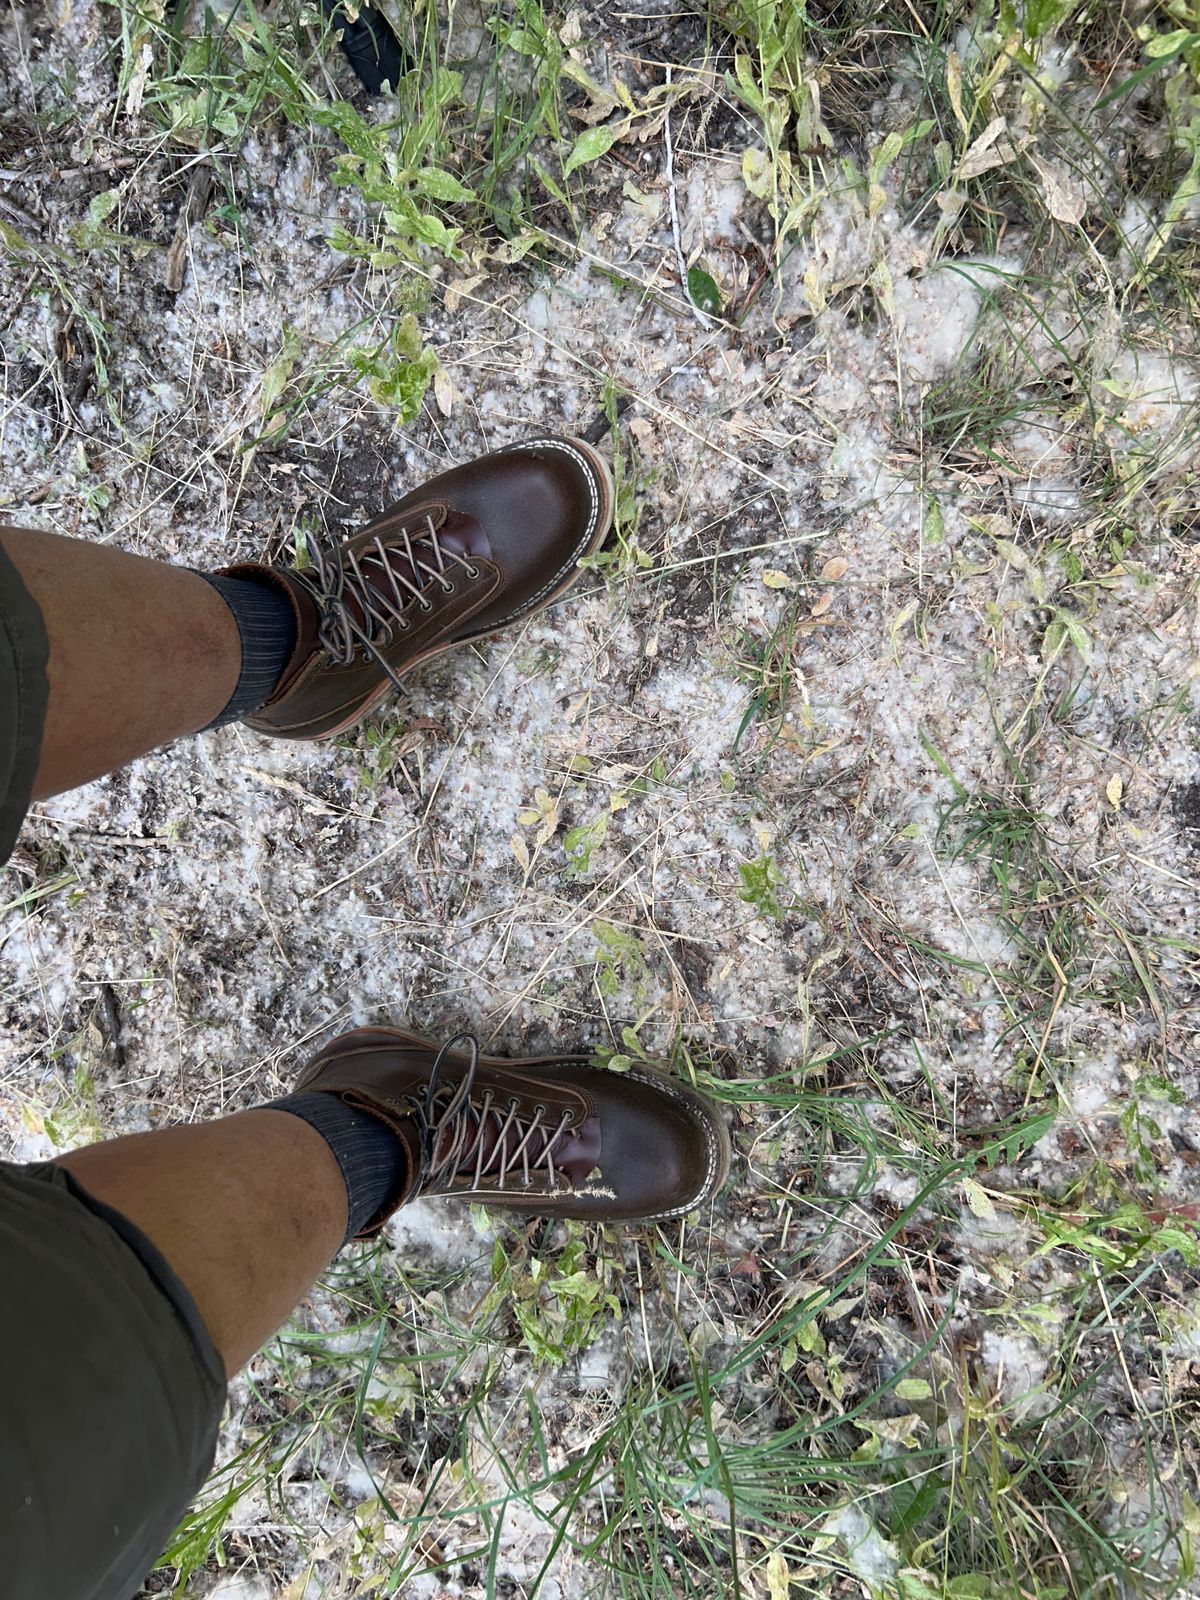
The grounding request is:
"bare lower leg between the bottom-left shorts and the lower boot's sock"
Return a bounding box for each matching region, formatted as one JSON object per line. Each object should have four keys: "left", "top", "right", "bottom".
{"left": 61, "top": 1110, "right": 346, "bottom": 1373}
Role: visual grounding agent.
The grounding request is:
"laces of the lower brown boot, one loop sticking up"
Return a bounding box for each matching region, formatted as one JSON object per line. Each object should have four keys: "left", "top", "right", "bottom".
{"left": 410, "top": 1034, "right": 571, "bottom": 1194}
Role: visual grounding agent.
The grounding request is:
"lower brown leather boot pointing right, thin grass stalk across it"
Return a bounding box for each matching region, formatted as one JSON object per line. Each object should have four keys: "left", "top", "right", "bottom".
{"left": 296, "top": 1027, "right": 730, "bottom": 1238}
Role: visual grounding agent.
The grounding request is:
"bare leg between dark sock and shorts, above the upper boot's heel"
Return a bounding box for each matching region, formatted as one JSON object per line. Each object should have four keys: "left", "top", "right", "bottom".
{"left": 3, "top": 528, "right": 242, "bottom": 798}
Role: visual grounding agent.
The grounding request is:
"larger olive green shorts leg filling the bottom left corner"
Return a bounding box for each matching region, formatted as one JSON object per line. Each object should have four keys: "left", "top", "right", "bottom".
{"left": 0, "top": 1163, "right": 226, "bottom": 1600}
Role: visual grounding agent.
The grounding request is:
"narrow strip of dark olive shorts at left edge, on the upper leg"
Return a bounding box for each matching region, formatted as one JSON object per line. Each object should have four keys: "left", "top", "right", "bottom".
{"left": 0, "top": 528, "right": 48, "bottom": 862}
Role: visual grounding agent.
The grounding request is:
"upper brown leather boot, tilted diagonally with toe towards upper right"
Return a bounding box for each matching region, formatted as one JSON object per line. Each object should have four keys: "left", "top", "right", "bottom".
{"left": 227, "top": 438, "right": 613, "bottom": 739}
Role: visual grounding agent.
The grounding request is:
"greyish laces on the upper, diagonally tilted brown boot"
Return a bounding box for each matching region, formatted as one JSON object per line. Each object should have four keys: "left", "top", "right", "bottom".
{"left": 294, "top": 515, "right": 478, "bottom": 688}
